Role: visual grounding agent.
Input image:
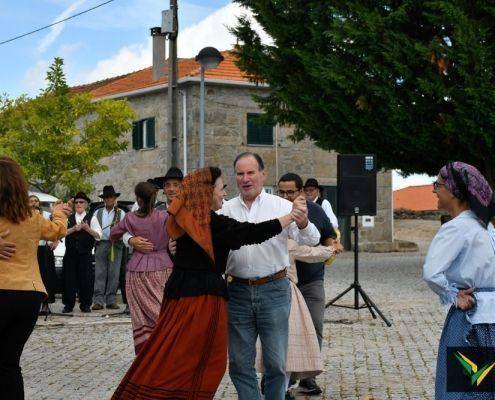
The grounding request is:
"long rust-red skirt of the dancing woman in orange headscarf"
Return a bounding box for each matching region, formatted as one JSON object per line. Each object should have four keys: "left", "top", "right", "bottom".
{"left": 112, "top": 295, "right": 227, "bottom": 400}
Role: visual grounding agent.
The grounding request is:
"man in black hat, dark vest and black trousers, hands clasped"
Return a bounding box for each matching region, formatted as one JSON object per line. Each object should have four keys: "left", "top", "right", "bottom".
{"left": 62, "top": 192, "right": 96, "bottom": 313}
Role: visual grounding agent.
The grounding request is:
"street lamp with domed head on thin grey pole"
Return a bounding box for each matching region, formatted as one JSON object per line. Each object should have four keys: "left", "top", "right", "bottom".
{"left": 196, "top": 47, "right": 223, "bottom": 168}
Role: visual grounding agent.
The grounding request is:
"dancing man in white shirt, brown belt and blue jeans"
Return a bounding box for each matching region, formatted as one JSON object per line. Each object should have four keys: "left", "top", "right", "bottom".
{"left": 220, "top": 153, "right": 320, "bottom": 400}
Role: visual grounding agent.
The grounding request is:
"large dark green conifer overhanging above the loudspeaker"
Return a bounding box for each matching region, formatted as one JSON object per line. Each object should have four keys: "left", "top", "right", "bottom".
{"left": 232, "top": 0, "right": 495, "bottom": 183}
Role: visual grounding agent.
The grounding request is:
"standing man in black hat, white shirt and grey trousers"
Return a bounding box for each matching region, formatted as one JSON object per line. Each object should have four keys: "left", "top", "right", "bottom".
{"left": 91, "top": 185, "right": 125, "bottom": 310}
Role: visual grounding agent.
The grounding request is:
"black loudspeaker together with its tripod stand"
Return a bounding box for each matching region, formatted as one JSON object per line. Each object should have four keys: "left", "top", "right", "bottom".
{"left": 325, "top": 154, "right": 391, "bottom": 326}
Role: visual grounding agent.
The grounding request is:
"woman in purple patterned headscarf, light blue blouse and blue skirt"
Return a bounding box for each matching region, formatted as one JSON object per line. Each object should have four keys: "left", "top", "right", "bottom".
{"left": 423, "top": 161, "right": 495, "bottom": 400}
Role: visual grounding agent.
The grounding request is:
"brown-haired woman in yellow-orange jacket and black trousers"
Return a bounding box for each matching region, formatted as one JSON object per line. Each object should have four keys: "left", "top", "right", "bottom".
{"left": 0, "top": 156, "right": 70, "bottom": 400}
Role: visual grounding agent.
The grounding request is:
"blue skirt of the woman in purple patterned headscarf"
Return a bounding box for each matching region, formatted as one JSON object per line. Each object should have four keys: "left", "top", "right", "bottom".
{"left": 435, "top": 306, "right": 495, "bottom": 400}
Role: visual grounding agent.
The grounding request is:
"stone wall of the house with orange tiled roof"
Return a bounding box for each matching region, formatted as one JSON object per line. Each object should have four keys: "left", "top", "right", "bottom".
{"left": 92, "top": 83, "right": 392, "bottom": 243}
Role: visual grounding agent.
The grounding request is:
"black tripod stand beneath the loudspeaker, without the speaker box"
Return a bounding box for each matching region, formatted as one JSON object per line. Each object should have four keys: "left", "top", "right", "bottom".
{"left": 325, "top": 212, "right": 392, "bottom": 326}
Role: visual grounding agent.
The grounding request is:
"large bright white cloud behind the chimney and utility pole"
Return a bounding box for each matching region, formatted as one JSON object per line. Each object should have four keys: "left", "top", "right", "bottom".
{"left": 78, "top": 3, "right": 269, "bottom": 83}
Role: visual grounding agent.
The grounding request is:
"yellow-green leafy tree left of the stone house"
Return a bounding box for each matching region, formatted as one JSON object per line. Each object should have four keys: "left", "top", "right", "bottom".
{"left": 0, "top": 58, "right": 135, "bottom": 196}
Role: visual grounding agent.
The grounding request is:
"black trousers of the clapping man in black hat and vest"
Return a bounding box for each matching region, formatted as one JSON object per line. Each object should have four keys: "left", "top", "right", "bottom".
{"left": 62, "top": 253, "right": 94, "bottom": 309}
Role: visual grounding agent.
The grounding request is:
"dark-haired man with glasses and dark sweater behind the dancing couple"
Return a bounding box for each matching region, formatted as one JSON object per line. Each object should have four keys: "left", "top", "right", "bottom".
{"left": 278, "top": 173, "right": 342, "bottom": 395}
